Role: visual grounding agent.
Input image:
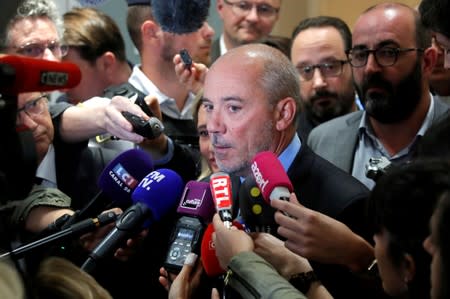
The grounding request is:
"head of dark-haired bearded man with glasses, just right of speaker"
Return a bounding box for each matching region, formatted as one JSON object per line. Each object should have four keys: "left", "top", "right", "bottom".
{"left": 290, "top": 16, "right": 359, "bottom": 142}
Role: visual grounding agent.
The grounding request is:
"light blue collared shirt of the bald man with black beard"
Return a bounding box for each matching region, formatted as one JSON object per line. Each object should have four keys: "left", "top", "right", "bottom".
{"left": 352, "top": 94, "right": 436, "bottom": 189}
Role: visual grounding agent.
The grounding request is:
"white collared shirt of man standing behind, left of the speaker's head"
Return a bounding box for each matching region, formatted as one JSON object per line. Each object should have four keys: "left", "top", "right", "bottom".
{"left": 128, "top": 65, "right": 195, "bottom": 119}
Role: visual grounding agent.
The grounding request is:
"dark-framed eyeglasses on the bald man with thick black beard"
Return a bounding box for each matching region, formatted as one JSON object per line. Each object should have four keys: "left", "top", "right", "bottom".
{"left": 347, "top": 46, "right": 423, "bottom": 67}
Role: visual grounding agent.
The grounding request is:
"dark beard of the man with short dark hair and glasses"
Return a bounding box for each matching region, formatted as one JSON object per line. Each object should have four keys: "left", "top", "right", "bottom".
{"left": 303, "top": 90, "right": 355, "bottom": 124}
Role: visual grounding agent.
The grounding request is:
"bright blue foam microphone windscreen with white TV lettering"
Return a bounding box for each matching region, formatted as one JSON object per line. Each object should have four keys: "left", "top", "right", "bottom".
{"left": 131, "top": 168, "right": 183, "bottom": 225}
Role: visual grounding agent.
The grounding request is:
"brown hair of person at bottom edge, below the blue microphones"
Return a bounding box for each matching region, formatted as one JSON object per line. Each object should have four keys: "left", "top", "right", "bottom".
{"left": 34, "top": 256, "right": 112, "bottom": 299}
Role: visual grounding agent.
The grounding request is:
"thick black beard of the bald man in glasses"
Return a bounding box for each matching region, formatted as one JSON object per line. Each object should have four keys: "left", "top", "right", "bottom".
{"left": 355, "top": 59, "right": 422, "bottom": 124}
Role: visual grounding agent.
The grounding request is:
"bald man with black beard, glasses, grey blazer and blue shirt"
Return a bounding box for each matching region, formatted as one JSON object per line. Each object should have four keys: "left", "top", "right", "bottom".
{"left": 308, "top": 3, "right": 449, "bottom": 189}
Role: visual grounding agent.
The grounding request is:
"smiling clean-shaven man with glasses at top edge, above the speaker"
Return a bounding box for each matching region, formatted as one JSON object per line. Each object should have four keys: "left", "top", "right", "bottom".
{"left": 211, "top": 0, "right": 281, "bottom": 62}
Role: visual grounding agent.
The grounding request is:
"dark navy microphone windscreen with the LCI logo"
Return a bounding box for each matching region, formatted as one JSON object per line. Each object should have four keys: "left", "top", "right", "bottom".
{"left": 98, "top": 149, "right": 153, "bottom": 203}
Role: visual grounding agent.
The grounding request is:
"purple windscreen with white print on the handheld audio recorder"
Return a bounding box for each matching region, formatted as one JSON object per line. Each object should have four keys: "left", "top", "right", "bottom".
{"left": 177, "top": 181, "right": 216, "bottom": 223}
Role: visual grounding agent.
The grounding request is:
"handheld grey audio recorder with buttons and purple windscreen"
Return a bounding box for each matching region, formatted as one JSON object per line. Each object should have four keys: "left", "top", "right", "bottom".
{"left": 164, "top": 181, "right": 216, "bottom": 274}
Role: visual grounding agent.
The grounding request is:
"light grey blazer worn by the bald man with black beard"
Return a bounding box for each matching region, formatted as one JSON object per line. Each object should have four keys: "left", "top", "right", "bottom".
{"left": 307, "top": 97, "right": 449, "bottom": 173}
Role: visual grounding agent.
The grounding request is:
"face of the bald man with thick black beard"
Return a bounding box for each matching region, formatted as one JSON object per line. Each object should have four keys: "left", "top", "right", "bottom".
{"left": 353, "top": 9, "right": 423, "bottom": 124}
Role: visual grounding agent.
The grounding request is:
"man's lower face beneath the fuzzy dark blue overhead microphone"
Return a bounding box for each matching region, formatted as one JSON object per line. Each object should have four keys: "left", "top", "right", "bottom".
{"left": 161, "top": 22, "right": 214, "bottom": 65}
